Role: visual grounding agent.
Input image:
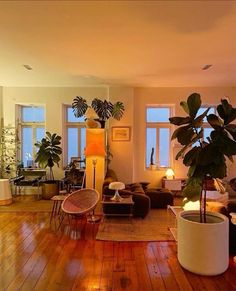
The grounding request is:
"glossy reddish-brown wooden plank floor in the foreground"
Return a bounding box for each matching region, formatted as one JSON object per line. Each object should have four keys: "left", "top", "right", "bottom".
{"left": 0, "top": 212, "right": 236, "bottom": 291}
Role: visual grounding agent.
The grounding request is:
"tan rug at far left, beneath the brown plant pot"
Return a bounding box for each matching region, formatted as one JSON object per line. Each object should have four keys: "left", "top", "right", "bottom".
{"left": 0, "top": 195, "right": 53, "bottom": 213}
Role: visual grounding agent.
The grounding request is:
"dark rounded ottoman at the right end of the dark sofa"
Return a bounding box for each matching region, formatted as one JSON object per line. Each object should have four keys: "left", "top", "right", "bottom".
{"left": 145, "top": 188, "right": 174, "bottom": 208}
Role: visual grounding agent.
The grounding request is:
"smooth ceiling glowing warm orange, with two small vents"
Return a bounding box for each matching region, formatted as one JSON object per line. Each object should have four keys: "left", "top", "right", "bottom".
{"left": 0, "top": 1, "right": 236, "bottom": 87}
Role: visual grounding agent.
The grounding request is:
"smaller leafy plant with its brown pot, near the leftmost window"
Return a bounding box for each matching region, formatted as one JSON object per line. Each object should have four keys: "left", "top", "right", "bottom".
{"left": 35, "top": 131, "right": 62, "bottom": 199}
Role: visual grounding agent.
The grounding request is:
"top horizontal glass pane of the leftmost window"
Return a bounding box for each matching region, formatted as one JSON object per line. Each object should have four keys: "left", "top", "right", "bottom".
{"left": 22, "top": 106, "right": 45, "bottom": 122}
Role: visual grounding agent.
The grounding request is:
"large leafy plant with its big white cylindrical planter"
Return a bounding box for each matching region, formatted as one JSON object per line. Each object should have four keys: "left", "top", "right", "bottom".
{"left": 170, "top": 93, "right": 236, "bottom": 275}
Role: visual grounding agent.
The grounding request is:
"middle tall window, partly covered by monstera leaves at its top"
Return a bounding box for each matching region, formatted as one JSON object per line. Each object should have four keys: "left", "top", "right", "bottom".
{"left": 64, "top": 106, "right": 86, "bottom": 164}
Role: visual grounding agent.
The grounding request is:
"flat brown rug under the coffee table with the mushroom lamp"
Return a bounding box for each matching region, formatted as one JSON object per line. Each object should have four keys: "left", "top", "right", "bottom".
{"left": 96, "top": 209, "right": 175, "bottom": 241}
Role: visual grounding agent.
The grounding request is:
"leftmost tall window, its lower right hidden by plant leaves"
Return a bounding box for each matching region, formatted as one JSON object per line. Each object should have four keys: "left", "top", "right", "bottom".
{"left": 19, "top": 105, "right": 45, "bottom": 167}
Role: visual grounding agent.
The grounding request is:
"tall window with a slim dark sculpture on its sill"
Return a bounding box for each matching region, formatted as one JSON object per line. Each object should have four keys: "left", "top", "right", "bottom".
{"left": 146, "top": 106, "right": 172, "bottom": 168}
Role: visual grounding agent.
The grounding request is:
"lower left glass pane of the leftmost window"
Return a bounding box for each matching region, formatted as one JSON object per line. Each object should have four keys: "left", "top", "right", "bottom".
{"left": 22, "top": 127, "right": 33, "bottom": 167}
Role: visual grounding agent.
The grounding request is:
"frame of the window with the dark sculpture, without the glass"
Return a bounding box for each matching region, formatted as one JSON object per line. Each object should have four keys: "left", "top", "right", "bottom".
{"left": 145, "top": 104, "right": 175, "bottom": 170}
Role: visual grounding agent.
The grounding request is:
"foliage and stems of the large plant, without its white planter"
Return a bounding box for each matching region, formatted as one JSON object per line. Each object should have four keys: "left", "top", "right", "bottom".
{"left": 169, "top": 93, "right": 236, "bottom": 223}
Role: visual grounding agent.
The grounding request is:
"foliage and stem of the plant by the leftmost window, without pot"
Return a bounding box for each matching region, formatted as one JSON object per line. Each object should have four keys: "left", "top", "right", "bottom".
{"left": 35, "top": 131, "right": 62, "bottom": 180}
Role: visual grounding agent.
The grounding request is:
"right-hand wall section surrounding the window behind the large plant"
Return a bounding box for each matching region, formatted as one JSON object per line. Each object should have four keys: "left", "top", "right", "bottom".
{"left": 134, "top": 87, "right": 236, "bottom": 186}
